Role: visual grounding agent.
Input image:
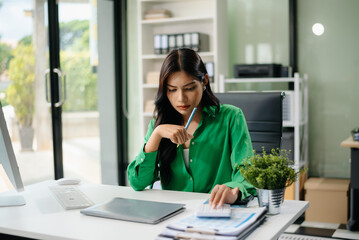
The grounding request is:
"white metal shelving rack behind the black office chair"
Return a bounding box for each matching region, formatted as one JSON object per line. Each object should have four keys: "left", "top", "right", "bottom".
{"left": 219, "top": 73, "right": 308, "bottom": 200}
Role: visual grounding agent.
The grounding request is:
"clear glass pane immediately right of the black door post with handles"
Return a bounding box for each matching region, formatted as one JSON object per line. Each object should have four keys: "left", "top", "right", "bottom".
{"left": 58, "top": 0, "right": 101, "bottom": 183}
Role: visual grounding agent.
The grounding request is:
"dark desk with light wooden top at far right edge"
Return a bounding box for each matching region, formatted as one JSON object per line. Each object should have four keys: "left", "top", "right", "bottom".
{"left": 340, "top": 137, "right": 359, "bottom": 231}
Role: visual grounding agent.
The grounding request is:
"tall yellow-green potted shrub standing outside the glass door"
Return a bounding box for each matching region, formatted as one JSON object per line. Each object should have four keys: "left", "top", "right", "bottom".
{"left": 6, "top": 42, "right": 35, "bottom": 150}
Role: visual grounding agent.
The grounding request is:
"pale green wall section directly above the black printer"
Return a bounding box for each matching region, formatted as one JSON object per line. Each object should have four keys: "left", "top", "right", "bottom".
{"left": 227, "top": 0, "right": 289, "bottom": 71}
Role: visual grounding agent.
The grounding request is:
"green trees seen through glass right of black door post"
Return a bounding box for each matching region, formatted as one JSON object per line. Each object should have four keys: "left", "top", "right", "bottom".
{"left": 60, "top": 20, "right": 98, "bottom": 111}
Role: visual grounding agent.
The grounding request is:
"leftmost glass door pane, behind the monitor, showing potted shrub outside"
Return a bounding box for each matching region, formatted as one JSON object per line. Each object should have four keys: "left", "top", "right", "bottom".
{"left": 0, "top": 0, "right": 54, "bottom": 185}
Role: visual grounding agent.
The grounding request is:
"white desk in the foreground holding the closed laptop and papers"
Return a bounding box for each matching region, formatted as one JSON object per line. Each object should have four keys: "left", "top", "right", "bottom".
{"left": 0, "top": 181, "right": 309, "bottom": 240}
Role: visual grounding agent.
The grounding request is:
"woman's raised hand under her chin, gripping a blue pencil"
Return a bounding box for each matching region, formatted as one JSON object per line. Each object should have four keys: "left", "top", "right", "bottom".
{"left": 144, "top": 124, "right": 193, "bottom": 153}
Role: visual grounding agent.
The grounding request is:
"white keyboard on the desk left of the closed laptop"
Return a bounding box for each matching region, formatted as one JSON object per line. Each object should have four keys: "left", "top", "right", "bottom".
{"left": 49, "top": 186, "right": 93, "bottom": 210}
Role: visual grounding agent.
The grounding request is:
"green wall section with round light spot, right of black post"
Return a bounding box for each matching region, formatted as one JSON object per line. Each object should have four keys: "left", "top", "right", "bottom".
{"left": 298, "top": 0, "right": 359, "bottom": 177}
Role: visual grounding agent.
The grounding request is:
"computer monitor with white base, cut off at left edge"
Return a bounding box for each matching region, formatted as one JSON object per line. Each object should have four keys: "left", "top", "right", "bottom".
{"left": 0, "top": 102, "right": 25, "bottom": 207}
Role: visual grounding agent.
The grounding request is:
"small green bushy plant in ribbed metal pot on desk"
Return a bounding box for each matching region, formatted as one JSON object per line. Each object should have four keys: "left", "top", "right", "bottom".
{"left": 240, "top": 149, "right": 306, "bottom": 214}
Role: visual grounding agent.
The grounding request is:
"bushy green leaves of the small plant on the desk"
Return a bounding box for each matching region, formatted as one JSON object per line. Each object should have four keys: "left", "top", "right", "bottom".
{"left": 239, "top": 149, "right": 307, "bottom": 190}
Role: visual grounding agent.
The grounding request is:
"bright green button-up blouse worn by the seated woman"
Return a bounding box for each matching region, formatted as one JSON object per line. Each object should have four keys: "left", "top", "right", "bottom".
{"left": 127, "top": 104, "right": 256, "bottom": 199}
